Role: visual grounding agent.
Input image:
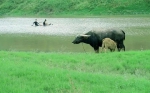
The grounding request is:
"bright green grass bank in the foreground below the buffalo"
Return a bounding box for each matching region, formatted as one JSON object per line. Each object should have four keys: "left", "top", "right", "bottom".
{"left": 0, "top": 51, "right": 150, "bottom": 93}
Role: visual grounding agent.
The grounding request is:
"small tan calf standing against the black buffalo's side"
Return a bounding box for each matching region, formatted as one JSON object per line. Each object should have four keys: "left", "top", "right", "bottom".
{"left": 102, "top": 38, "right": 117, "bottom": 52}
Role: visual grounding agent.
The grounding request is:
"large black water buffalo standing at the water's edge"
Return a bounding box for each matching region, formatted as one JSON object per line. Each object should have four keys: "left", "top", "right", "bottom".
{"left": 72, "top": 29, "right": 125, "bottom": 53}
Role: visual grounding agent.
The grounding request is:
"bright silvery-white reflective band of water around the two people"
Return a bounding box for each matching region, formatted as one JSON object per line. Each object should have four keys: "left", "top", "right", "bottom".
{"left": 0, "top": 18, "right": 150, "bottom": 35}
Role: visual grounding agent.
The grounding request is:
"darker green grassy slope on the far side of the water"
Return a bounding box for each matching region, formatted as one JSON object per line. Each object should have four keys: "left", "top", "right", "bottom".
{"left": 0, "top": 0, "right": 150, "bottom": 17}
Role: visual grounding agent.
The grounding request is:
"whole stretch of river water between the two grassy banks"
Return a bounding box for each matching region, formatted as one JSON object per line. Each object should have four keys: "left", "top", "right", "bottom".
{"left": 0, "top": 17, "right": 150, "bottom": 52}
